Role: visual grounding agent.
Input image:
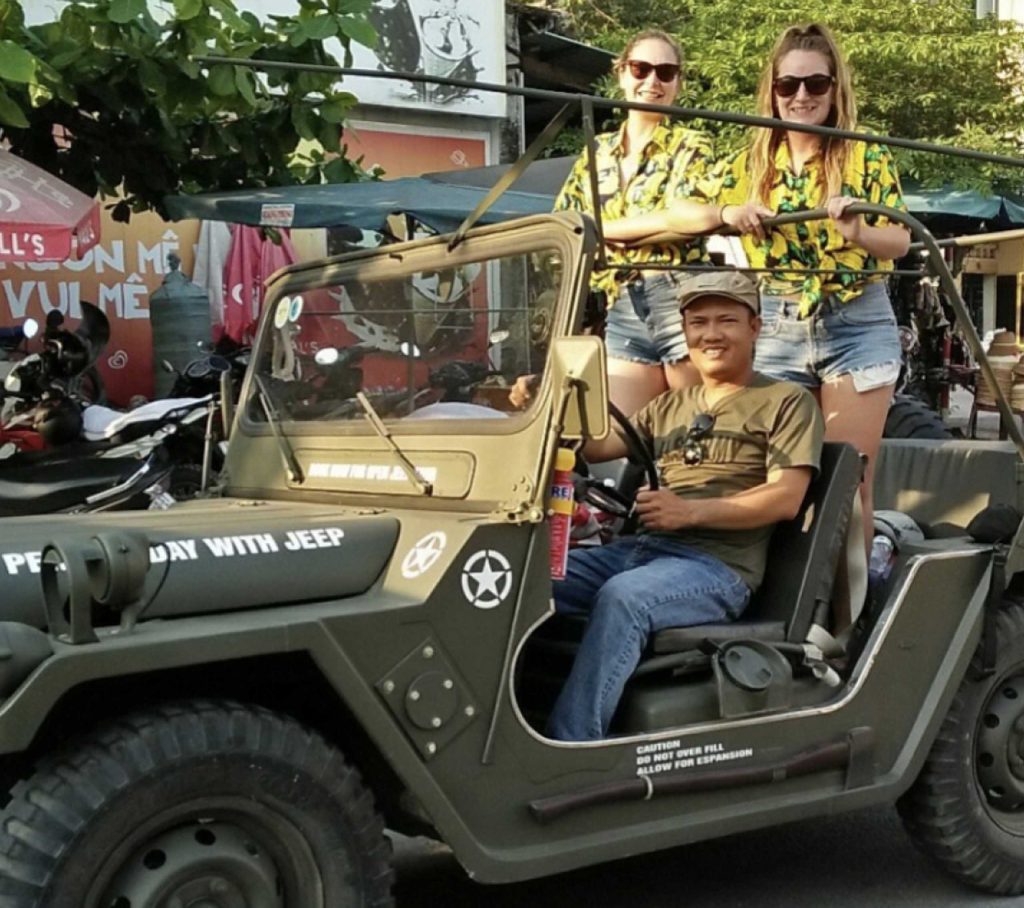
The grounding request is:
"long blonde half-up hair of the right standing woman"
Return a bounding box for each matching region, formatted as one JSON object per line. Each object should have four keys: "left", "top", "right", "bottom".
{"left": 748, "top": 23, "right": 857, "bottom": 204}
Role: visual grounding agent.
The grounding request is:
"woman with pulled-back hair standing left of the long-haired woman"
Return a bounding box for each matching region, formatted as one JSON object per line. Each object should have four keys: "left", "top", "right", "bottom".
{"left": 555, "top": 30, "right": 711, "bottom": 415}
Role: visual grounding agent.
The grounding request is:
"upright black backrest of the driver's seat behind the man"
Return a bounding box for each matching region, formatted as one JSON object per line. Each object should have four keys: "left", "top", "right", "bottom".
{"left": 742, "top": 442, "right": 863, "bottom": 643}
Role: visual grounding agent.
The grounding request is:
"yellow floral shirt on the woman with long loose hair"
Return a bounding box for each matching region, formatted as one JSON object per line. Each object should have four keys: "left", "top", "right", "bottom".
{"left": 695, "top": 142, "right": 906, "bottom": 317}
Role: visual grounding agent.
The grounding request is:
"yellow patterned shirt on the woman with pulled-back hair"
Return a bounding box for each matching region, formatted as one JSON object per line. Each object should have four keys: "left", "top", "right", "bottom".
{"left": 555, "top": 119, "right": 712, "bottom": 298}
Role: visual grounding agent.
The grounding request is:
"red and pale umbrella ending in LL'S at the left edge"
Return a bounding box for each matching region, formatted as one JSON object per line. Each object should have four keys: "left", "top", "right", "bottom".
{"left": 0, "top": 149, "right": 99, "bottom": 262}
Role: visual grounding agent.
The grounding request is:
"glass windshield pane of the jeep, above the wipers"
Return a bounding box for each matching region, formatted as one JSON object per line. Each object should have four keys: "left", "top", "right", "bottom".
{"left": 246, "top": 237, "right": 563, "bottom": 431}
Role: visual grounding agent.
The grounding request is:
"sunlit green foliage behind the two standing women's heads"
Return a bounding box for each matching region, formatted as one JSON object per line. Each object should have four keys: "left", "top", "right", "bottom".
{"left": 557, "top": 0, "right": 1024, "bottom": 195}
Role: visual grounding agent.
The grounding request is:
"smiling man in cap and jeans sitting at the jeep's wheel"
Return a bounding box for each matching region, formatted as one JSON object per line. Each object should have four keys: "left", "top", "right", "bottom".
{"left": 548, "top": 271, "right": 823, "bottom": 741}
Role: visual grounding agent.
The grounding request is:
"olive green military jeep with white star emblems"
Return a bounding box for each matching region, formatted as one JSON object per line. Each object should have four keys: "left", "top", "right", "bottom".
{"left": 0, "top": 205, "right": 1024, "bottom": 908}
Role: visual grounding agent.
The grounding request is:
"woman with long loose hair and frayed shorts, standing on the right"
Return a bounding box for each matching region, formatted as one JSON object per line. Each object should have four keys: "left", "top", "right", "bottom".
{"left": 605, "top": 25, "right": 910, "bottom": 539}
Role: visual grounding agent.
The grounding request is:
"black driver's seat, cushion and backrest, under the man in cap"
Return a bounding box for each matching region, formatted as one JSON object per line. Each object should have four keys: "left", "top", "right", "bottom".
{"left": 638, "top": 442, "right": 863, "bottom": 674}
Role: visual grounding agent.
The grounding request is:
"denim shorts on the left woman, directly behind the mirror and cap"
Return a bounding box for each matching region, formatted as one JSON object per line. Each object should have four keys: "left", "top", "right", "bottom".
{"left": 604, "top": 271, "right": 686, "bottom": 365}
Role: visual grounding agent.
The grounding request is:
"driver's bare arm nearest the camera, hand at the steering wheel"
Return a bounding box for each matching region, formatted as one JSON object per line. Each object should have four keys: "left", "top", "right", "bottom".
{"left": 637, "top": 467, "right": 813, "bottom": 530}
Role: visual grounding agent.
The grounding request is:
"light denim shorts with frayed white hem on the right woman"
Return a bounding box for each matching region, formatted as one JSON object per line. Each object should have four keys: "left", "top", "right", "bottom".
{"left": 755, "top": 282, "right": 902, "bottom": 392}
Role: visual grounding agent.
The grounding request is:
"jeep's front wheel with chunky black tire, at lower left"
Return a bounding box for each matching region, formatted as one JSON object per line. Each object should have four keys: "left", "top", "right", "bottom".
{"left": 0, "top": 701, "right": 393, "bottom": 908}
